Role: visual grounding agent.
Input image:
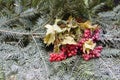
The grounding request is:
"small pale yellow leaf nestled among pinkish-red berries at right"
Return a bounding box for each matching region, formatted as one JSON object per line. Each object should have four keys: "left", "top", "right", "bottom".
{"left": 83, "top": 39, "right": 96, "bottom": 54}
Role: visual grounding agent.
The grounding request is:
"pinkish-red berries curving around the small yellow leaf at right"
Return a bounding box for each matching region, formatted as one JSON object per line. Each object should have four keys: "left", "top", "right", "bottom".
{"left": 78, "top": 29, "right": 103, "bottom": 61}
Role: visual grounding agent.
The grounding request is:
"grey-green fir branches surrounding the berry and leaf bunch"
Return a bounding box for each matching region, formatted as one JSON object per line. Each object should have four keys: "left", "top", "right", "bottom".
{"left": 0, "top": 0, "right": 120, "bottom": 80}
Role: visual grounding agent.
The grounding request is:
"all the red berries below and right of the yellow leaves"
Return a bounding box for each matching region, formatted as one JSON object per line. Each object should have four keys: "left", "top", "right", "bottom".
{"left": 49, "top": 29, "right": 103, "bottom": 62}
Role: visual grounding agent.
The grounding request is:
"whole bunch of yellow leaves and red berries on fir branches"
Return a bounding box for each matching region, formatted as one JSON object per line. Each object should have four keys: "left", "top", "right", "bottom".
{"left": 44, "top": 16, "right": 103, "bottom": 62}
